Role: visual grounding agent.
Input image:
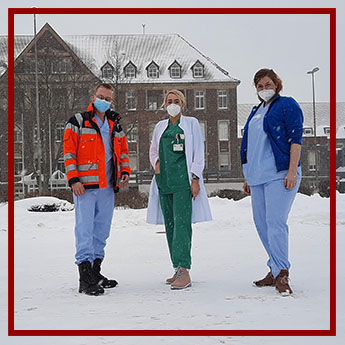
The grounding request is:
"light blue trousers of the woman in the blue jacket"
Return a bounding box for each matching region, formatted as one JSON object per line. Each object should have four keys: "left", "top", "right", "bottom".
{"left": 250, "top": 175, "right": 301, "bottom": 277}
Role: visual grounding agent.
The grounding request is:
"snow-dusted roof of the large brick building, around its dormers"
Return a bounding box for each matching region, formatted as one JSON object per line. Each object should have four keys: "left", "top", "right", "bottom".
{"left": 0, "top": 24, "right": 240, "bottom": 83}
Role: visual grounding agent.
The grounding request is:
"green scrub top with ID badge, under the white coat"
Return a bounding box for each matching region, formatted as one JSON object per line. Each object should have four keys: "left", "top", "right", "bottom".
{"left": 156, "top": 120, "right": 190, "bottom": 194}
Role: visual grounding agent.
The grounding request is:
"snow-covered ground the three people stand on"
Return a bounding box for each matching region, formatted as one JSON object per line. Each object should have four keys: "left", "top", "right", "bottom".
{"left": 0, "top": 194, "right": 345, "bottom": 345}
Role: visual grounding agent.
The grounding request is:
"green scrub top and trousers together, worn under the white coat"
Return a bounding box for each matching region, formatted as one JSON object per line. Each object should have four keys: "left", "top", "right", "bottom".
{"left": 156, "top": 121, "right": 192, "bottom": 269}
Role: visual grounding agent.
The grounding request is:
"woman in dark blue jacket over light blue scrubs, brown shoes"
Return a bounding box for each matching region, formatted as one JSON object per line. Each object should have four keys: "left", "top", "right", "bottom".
{"left": 241, "top": 69, "right": 303, "bottom": 296}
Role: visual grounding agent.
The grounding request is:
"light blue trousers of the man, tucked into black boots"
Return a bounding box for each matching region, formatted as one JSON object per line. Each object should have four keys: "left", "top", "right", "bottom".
{"left": 73, "top": 188, "right": 114, "bottom": 265}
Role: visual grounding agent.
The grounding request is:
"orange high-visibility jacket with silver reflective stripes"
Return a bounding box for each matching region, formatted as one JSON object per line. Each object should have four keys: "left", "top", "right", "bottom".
{"left": 64, "top": 104, "right": 131, "bottom": 192}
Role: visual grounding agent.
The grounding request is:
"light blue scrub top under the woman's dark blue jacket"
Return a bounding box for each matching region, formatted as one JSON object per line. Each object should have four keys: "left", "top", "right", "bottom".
{"left": 243, "top": 103, "right": 288, "bottom": 186}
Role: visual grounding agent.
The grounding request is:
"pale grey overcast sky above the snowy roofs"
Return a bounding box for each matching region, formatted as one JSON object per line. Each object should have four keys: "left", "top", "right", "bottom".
{"left": 0, "top": 0, "right": 345, "bottom": 103}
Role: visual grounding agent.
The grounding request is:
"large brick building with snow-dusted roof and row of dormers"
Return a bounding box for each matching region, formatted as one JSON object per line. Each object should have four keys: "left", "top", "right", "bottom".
{"left": 0, "top": 24, "right": 241, "bottom": 196}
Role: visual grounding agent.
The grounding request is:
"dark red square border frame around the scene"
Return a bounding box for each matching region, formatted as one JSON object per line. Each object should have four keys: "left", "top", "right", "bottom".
{"left": 8, "top": 8, "right": 336, "bottom": 336}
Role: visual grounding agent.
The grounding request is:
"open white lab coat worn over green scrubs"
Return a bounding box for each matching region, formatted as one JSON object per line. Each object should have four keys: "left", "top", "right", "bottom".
{"left": 146, "top": 115, "right": 212, "bottom": 224}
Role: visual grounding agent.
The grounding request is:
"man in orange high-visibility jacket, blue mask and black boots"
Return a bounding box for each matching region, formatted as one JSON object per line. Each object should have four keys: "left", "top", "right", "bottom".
{"left": 64, "top": 84, "right": 131, "bottom": 295}
